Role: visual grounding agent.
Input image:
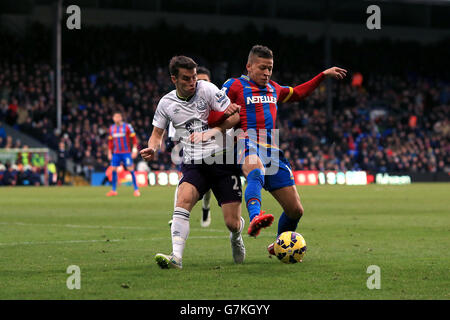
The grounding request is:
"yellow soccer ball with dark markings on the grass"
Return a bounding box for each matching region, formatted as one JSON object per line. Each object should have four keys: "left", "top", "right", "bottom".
{"left": 274, "top": 231, "right": 306, "bottom": 263}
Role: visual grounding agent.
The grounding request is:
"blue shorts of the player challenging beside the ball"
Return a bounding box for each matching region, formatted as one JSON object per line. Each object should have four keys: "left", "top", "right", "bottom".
{"left": 236, "top": 138, "right": 295, "bottom": 191}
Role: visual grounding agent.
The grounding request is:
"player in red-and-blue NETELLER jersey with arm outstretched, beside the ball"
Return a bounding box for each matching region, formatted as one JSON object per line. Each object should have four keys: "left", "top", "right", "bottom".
{"left": 220, "top": 45, "right": 347, "bottom": 254}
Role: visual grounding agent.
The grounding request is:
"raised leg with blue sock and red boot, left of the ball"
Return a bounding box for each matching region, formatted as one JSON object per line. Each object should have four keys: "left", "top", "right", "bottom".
{"left": 242, "top": 154, "right": 274, "bottom": 237}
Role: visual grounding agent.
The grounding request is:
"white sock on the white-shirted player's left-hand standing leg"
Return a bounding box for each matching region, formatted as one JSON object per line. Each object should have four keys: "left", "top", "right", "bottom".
{"left": 170, "top": 207, "right": 190, "bottom": 259}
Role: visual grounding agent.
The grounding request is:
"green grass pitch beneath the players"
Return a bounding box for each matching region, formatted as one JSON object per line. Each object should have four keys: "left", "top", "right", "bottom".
{"left": 0, "top": 184, "right": 450, "bottom": 300}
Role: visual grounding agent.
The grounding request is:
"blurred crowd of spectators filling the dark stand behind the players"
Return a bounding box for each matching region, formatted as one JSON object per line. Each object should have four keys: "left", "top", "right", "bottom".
{"left": 0, "top": 25, "right": 450, "bottom": 181}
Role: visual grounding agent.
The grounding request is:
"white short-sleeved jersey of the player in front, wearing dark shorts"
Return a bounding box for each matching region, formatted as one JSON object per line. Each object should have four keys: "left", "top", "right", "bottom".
{"left": 152, "top": 81, "right": 231, "bottom": 162}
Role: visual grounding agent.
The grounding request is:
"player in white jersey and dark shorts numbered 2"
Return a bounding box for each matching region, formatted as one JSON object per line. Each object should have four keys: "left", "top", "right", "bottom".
{"left": 140, "top": 56, "right": 245, "bottom": 269}
